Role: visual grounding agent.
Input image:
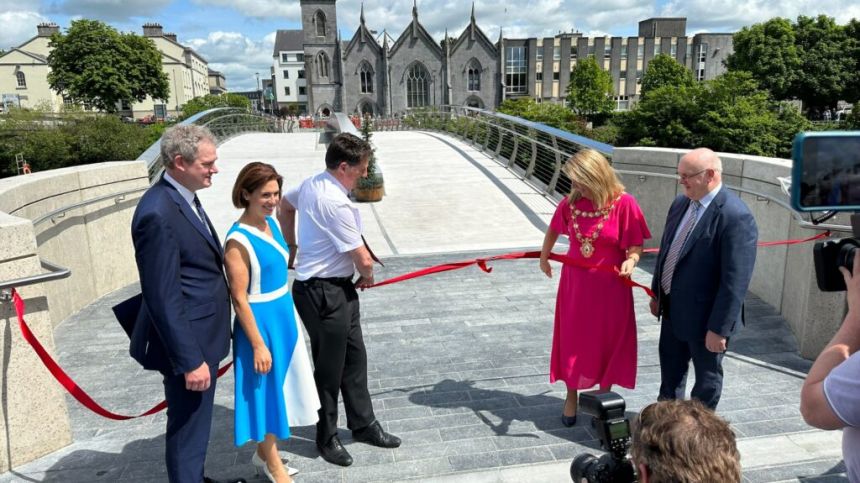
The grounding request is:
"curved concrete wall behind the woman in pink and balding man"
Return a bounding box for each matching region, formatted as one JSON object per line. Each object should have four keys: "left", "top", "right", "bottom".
{"left": 613, "top": 148, "right": 849, "bottom": 359}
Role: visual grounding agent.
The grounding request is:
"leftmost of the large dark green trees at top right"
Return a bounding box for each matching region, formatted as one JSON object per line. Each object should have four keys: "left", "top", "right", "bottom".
{"left": 726, "top": 17, "right": 801, "bottom": 99}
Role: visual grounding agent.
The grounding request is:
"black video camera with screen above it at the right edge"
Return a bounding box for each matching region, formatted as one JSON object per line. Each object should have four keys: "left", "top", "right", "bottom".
{"left": 791, "top": 131, "right": 860, "bottom": 292}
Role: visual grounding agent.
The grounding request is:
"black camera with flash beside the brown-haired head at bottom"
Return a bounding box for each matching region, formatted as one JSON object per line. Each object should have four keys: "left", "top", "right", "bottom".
{"left": 570, "top": 391, "right": 636, "bottom": 483}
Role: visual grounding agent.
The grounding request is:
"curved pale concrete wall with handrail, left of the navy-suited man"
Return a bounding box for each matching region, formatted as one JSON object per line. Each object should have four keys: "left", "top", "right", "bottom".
{"left": 0, "top": 161, "right": 149, "bottom": 472}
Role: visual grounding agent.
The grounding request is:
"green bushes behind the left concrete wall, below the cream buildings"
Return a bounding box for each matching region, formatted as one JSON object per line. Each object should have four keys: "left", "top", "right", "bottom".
{"left": 0, "top": 110, "right": 164, "bottom": 177}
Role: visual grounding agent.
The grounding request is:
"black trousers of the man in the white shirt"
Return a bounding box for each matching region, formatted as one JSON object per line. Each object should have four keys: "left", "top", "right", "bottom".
{"left": 293, "top": 277, "right": 376, "bottom": 445}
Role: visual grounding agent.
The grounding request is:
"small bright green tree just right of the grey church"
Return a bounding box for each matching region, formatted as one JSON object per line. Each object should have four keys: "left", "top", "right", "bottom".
{"left": 567, "top": 56, "right": 615, "bottom": 120}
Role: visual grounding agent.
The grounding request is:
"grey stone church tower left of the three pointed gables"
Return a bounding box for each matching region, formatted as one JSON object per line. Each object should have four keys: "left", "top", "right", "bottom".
{"left": 299, "top": 0, "right": 343, "bottom": 115}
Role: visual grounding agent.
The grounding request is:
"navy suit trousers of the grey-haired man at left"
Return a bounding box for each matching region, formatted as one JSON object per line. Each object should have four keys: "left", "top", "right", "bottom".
{"left": 164, "top": 364, "right": 218, "bottom": 483}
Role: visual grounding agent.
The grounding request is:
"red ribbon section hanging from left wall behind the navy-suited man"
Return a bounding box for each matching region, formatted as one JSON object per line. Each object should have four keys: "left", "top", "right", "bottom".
{"left": 12, "top": 288, "right": 233, "bottom": 421}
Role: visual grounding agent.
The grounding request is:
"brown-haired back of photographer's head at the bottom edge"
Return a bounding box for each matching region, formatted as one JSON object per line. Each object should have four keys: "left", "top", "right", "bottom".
{"left": 631, "top": 400, "right": 741, "bottom": 483}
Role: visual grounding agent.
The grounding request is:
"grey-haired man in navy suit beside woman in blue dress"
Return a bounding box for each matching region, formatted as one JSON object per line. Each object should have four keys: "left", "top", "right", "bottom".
{"left": 130, "top": 126, "right": 242, "bottom": 483}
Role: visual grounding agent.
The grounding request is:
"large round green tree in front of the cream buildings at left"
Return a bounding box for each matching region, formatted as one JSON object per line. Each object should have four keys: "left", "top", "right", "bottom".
{"left": 48, "top": 20, "right": 170, "bottom": 112}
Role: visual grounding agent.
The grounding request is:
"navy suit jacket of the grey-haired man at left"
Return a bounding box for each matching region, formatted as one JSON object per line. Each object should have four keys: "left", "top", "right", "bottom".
{"left": 130, "top": 178, "right": 231, "bottom": 375}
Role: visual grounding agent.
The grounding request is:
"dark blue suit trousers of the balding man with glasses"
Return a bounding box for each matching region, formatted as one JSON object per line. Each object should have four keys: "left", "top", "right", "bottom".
{"left": 658, "top": 294, "right": 728, "bottom": 410}
